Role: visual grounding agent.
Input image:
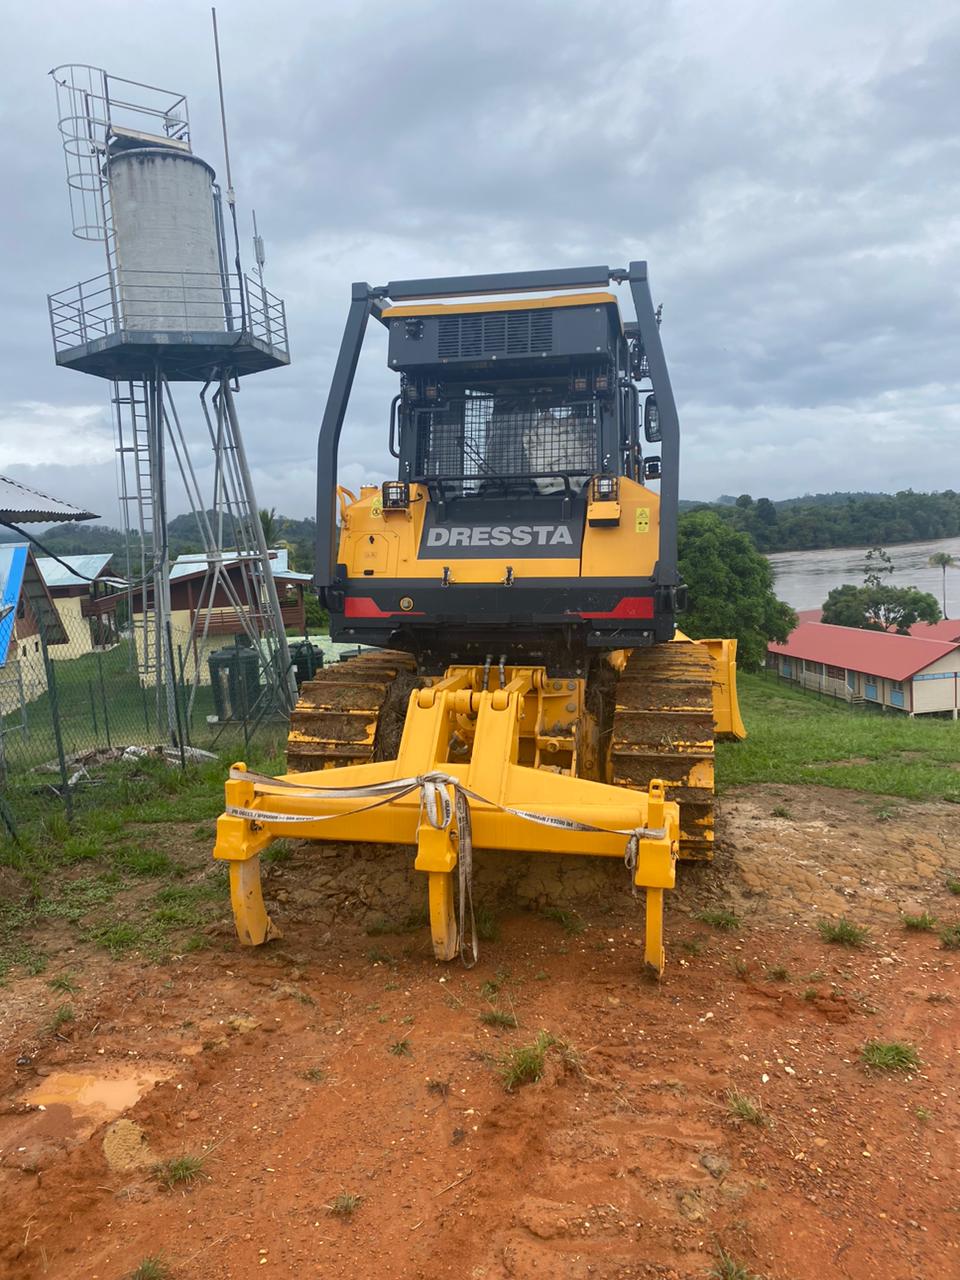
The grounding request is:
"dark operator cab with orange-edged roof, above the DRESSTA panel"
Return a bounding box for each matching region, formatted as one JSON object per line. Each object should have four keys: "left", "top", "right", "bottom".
{"left": 383, "top": 293, "right": 641, "bottom": 507}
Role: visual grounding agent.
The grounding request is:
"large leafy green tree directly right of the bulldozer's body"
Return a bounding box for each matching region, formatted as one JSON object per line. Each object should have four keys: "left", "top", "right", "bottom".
{"left": 678, "top": 511, "right": 796, "bottom": 669}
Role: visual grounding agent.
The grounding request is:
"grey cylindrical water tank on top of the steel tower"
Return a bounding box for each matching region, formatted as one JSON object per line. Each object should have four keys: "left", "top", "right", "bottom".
{"left": 106, "top": 147, "right": 225, "bottom": 333}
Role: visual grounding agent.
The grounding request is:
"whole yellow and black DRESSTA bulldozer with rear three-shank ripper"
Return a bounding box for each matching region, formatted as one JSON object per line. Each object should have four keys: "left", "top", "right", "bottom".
{"left": 214, "top": 262, "right": 744, "bottom": 975}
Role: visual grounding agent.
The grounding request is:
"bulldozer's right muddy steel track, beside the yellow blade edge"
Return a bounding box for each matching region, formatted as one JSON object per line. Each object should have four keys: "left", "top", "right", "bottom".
{"left": 609, "top": 640, "right": 714, "bottom": 859}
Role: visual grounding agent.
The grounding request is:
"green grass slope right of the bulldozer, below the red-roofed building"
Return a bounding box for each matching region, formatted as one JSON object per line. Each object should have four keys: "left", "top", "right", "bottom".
{"left": 717, "top": 672, "right": 960, "bottom": 803}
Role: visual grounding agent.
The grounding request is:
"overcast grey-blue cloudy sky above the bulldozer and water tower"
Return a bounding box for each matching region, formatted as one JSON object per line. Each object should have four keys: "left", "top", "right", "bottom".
{"left": 0, "top": 0, "right": 960, "bottom": 522}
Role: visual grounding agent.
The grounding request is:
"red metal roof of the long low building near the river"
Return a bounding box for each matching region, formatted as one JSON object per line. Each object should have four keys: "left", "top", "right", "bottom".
{"left": 767, "top": 622, "right": 960, "bottom": 680}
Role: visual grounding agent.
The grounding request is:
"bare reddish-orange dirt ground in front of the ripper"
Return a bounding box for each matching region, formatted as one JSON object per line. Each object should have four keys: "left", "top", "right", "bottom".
{"left": 0, "top": 787, "right": 960, "bottom": 1280}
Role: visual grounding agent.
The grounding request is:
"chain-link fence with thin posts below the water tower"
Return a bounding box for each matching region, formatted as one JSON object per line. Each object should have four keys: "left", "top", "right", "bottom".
{"left": 0, "top": 598, "right": 356, "bottom": 832}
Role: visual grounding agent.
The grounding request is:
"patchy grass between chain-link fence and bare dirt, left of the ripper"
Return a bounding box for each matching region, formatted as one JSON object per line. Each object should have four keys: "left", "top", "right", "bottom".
{"left": 0, "top": 742, "right": 288, "bottom": 967}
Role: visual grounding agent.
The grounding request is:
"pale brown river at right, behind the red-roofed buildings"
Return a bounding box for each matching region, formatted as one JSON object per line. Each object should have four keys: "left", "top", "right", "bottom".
{"left": 767, "top": 538, "right": 960, "bottom": 618}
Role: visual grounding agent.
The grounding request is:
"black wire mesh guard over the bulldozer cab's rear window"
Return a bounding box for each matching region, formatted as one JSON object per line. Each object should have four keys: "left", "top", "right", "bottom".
{"left": 413, "top": 392, "right": 602, "bottom": 495}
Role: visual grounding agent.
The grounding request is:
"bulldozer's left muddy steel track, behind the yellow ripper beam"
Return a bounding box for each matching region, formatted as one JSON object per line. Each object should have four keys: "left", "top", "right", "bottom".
{"left": 287, "top": 650, "right": 417, "bottom": 773}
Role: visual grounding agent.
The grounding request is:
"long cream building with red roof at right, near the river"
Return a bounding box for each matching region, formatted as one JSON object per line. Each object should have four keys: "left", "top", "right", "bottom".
{"left": 767, "top": 611, "right": 960, "bottom": 719}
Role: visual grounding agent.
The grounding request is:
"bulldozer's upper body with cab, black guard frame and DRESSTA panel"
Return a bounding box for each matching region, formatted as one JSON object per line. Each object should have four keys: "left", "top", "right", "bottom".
{"left": 317, "top": 264, "right": 682, "bottom": 675}
